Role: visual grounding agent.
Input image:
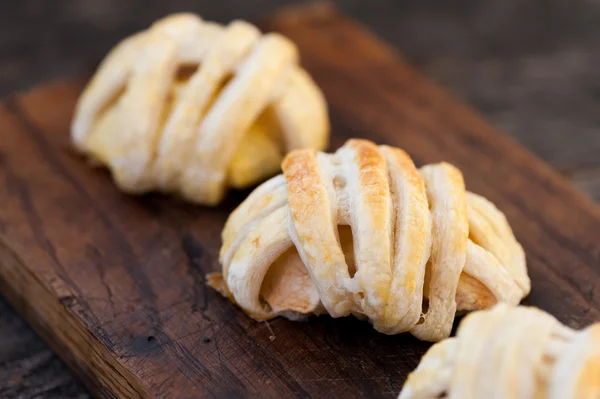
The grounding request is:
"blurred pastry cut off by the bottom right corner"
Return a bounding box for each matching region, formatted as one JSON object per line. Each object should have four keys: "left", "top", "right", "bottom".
{"left": 399, "top": 304, "right": 600, "bottom": 399}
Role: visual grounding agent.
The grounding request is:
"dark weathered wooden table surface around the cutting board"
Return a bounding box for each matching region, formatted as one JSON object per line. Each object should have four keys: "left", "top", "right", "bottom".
{"left": 0, "top": 0, "right": 600, "bottom": 398}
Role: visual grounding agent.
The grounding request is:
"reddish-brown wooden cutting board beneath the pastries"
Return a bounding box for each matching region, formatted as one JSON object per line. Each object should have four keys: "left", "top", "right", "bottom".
{"left": 0, "top": 5, "right": 600, "bottom": 398}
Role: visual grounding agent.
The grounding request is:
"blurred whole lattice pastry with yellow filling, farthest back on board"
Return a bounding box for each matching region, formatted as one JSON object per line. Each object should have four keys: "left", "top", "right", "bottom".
{"left": 72, "top": 14, "right": 329, "bottom": 205}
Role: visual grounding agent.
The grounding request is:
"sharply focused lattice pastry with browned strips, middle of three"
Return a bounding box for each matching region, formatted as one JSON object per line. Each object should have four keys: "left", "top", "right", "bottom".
{"left": 210, "top": 139, "right": 530, "bottom": 341}
